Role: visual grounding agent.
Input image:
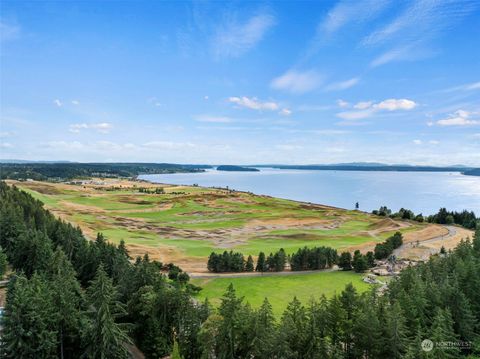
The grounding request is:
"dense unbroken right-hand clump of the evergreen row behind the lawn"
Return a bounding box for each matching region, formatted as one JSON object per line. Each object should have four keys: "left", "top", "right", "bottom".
{"left": 290, "top": 247, "right": 338, "bottom": 271}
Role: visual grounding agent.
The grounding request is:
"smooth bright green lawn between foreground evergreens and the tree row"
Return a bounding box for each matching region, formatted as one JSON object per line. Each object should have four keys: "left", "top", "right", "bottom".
{"left": 192, "top": 271, "right": 372, "bottom": 317}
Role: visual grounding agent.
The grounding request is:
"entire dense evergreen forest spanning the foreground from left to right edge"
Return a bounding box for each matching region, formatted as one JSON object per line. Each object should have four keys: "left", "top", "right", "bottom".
{"left": 0, "top": 182, "right": 480, "bottom": 359}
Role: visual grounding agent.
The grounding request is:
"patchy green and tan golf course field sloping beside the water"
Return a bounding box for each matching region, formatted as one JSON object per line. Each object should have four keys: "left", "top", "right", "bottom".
{"left": 8, "top": 179, "right": 454, "bottom": 273}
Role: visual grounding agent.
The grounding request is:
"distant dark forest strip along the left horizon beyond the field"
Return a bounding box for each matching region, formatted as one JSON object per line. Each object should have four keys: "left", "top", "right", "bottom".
{"left": 0, "top": 163, "right": 210, "bottom": 181}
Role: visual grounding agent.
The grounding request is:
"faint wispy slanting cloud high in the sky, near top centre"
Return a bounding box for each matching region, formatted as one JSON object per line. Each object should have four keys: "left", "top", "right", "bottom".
{"left": 212, "top": 14, "right": 275, "bottom": 58}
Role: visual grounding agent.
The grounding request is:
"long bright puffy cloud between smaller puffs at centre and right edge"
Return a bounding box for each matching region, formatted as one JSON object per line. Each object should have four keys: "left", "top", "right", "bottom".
{"left": 337, "top": 98, "right": 417, "bottom": 120}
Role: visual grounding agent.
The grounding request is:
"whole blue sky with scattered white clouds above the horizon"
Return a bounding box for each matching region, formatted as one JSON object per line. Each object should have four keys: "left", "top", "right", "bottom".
{"left": 0, "top": 0, "right": 480, "bottom": 166}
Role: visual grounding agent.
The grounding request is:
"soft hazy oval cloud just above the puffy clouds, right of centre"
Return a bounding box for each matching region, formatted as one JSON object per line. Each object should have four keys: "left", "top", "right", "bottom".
{"left": 270, "top": 70, "right": 322, "bottom": 94}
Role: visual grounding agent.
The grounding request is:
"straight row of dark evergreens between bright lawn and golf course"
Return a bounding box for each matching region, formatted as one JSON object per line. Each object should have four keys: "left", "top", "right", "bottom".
{"left": 207, "top": 247, "right": 338, "bottom": 273}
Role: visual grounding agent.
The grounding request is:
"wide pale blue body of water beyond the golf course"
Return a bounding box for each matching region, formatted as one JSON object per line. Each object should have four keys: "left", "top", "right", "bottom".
{"left": 139, "top": 168, "right": 480, "bottom": 215}
